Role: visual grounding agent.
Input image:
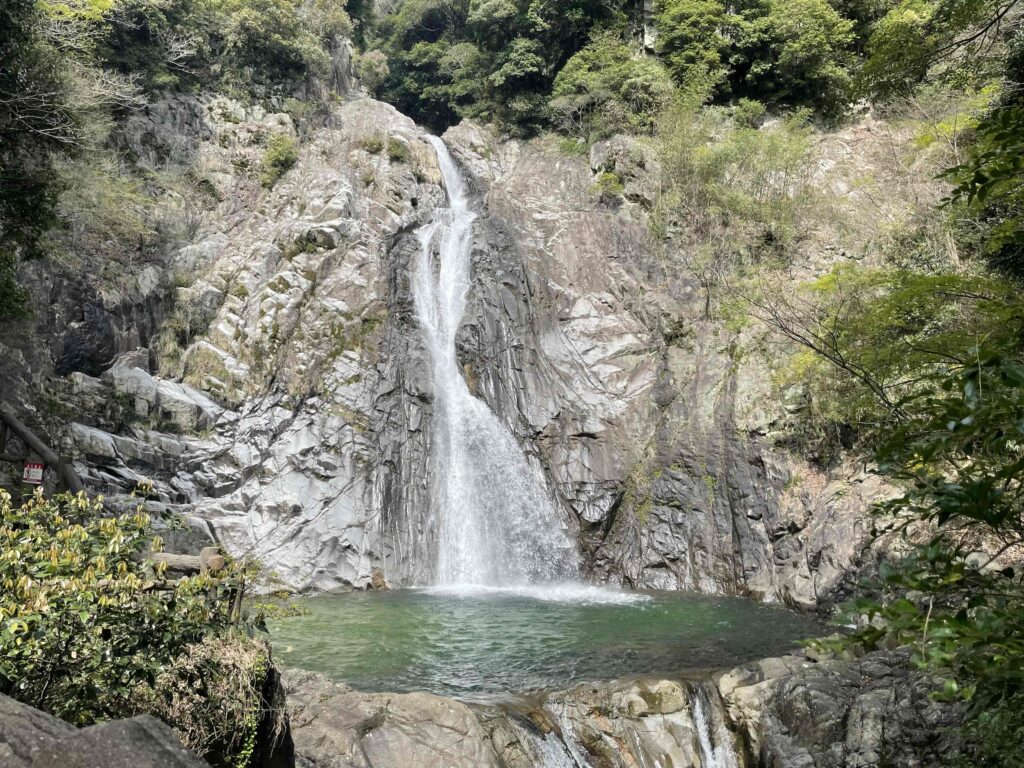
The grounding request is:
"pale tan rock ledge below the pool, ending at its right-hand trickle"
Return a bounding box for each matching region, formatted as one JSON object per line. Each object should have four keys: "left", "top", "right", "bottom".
{"left": 285, "top": 672, "right": 735, "bottom": 768}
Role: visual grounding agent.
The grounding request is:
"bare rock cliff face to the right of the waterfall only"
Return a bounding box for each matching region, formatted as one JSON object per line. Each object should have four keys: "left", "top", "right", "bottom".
{"left": 445, "top": 124, "right": 886, "bottom": 608}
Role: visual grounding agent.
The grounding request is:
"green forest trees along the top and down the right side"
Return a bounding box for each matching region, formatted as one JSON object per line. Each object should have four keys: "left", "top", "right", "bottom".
{"left": 0, "top": 0, "right": 1024, "bottom": 766}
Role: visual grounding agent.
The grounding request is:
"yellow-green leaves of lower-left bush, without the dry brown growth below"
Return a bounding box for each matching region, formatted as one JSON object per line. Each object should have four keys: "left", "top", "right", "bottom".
{"left": 0, "top": 492, "right": 234, "bottom": 724}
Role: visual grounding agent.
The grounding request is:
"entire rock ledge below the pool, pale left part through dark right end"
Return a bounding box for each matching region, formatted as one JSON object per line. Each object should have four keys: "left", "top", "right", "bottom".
{"left": 285, "top": 652, "right": 962, "bottom": 768}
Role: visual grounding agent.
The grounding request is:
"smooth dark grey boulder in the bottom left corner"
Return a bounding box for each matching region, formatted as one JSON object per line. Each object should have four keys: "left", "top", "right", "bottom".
{"left": 0, "top": 695, "right": 209, "bottom": 768}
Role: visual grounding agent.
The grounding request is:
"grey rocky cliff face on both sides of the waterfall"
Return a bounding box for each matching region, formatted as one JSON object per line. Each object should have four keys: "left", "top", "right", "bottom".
{"left": 3, "top": 69, "right": 883, "bottom": 607}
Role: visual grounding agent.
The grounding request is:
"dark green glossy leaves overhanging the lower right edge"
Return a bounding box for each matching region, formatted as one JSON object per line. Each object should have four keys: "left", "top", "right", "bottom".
{"left": 819, "top": 354, "right": 1024, "bottom": 729}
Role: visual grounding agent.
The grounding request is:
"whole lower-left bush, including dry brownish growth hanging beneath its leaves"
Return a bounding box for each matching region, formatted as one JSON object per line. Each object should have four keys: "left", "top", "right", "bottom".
{"left": 0, "top": 490, "right": 269, "bottom": 766}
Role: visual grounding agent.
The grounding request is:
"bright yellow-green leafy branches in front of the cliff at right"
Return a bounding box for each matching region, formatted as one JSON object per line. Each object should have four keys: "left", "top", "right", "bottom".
{"left": 755, "top": 265, "right": 1024, "bottom": 453}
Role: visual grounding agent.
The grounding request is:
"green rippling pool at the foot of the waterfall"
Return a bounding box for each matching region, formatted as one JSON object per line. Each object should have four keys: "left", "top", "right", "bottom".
{"left": 270, "top": 587, "right": 821, "bottom": 697}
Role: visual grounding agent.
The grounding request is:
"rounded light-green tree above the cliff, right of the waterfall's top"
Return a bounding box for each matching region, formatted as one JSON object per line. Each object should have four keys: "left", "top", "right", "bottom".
{"left": 551, "top": 33, "right": 673, "bottom": 140}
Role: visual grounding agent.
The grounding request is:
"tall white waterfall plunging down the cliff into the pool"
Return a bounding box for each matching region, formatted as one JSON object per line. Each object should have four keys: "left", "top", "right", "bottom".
{"left": 413, "top": 137, "right": 578, "bottom": 587}
